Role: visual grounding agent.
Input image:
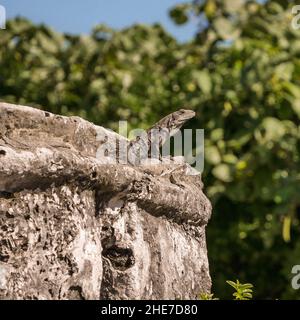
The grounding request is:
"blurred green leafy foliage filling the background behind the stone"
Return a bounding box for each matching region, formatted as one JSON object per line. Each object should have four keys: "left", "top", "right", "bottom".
{"left": 0, "top": 0, "right": 300, "bottom": 298}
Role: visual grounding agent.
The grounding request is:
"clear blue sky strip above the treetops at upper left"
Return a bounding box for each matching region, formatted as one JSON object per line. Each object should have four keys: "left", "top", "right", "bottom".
{"left": 0, "top": 0, "right": 197, "bottom": 41}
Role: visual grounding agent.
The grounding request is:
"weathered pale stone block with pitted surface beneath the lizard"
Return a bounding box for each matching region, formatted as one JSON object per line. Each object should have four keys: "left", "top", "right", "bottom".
{"left": 0, "top": 103, "right": 211, "bottom": 299}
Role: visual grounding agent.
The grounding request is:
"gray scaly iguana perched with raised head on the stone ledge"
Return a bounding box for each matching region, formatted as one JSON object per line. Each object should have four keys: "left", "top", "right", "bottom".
{"left": 127, "top": 109, "right": 195, "bottom": 165}
